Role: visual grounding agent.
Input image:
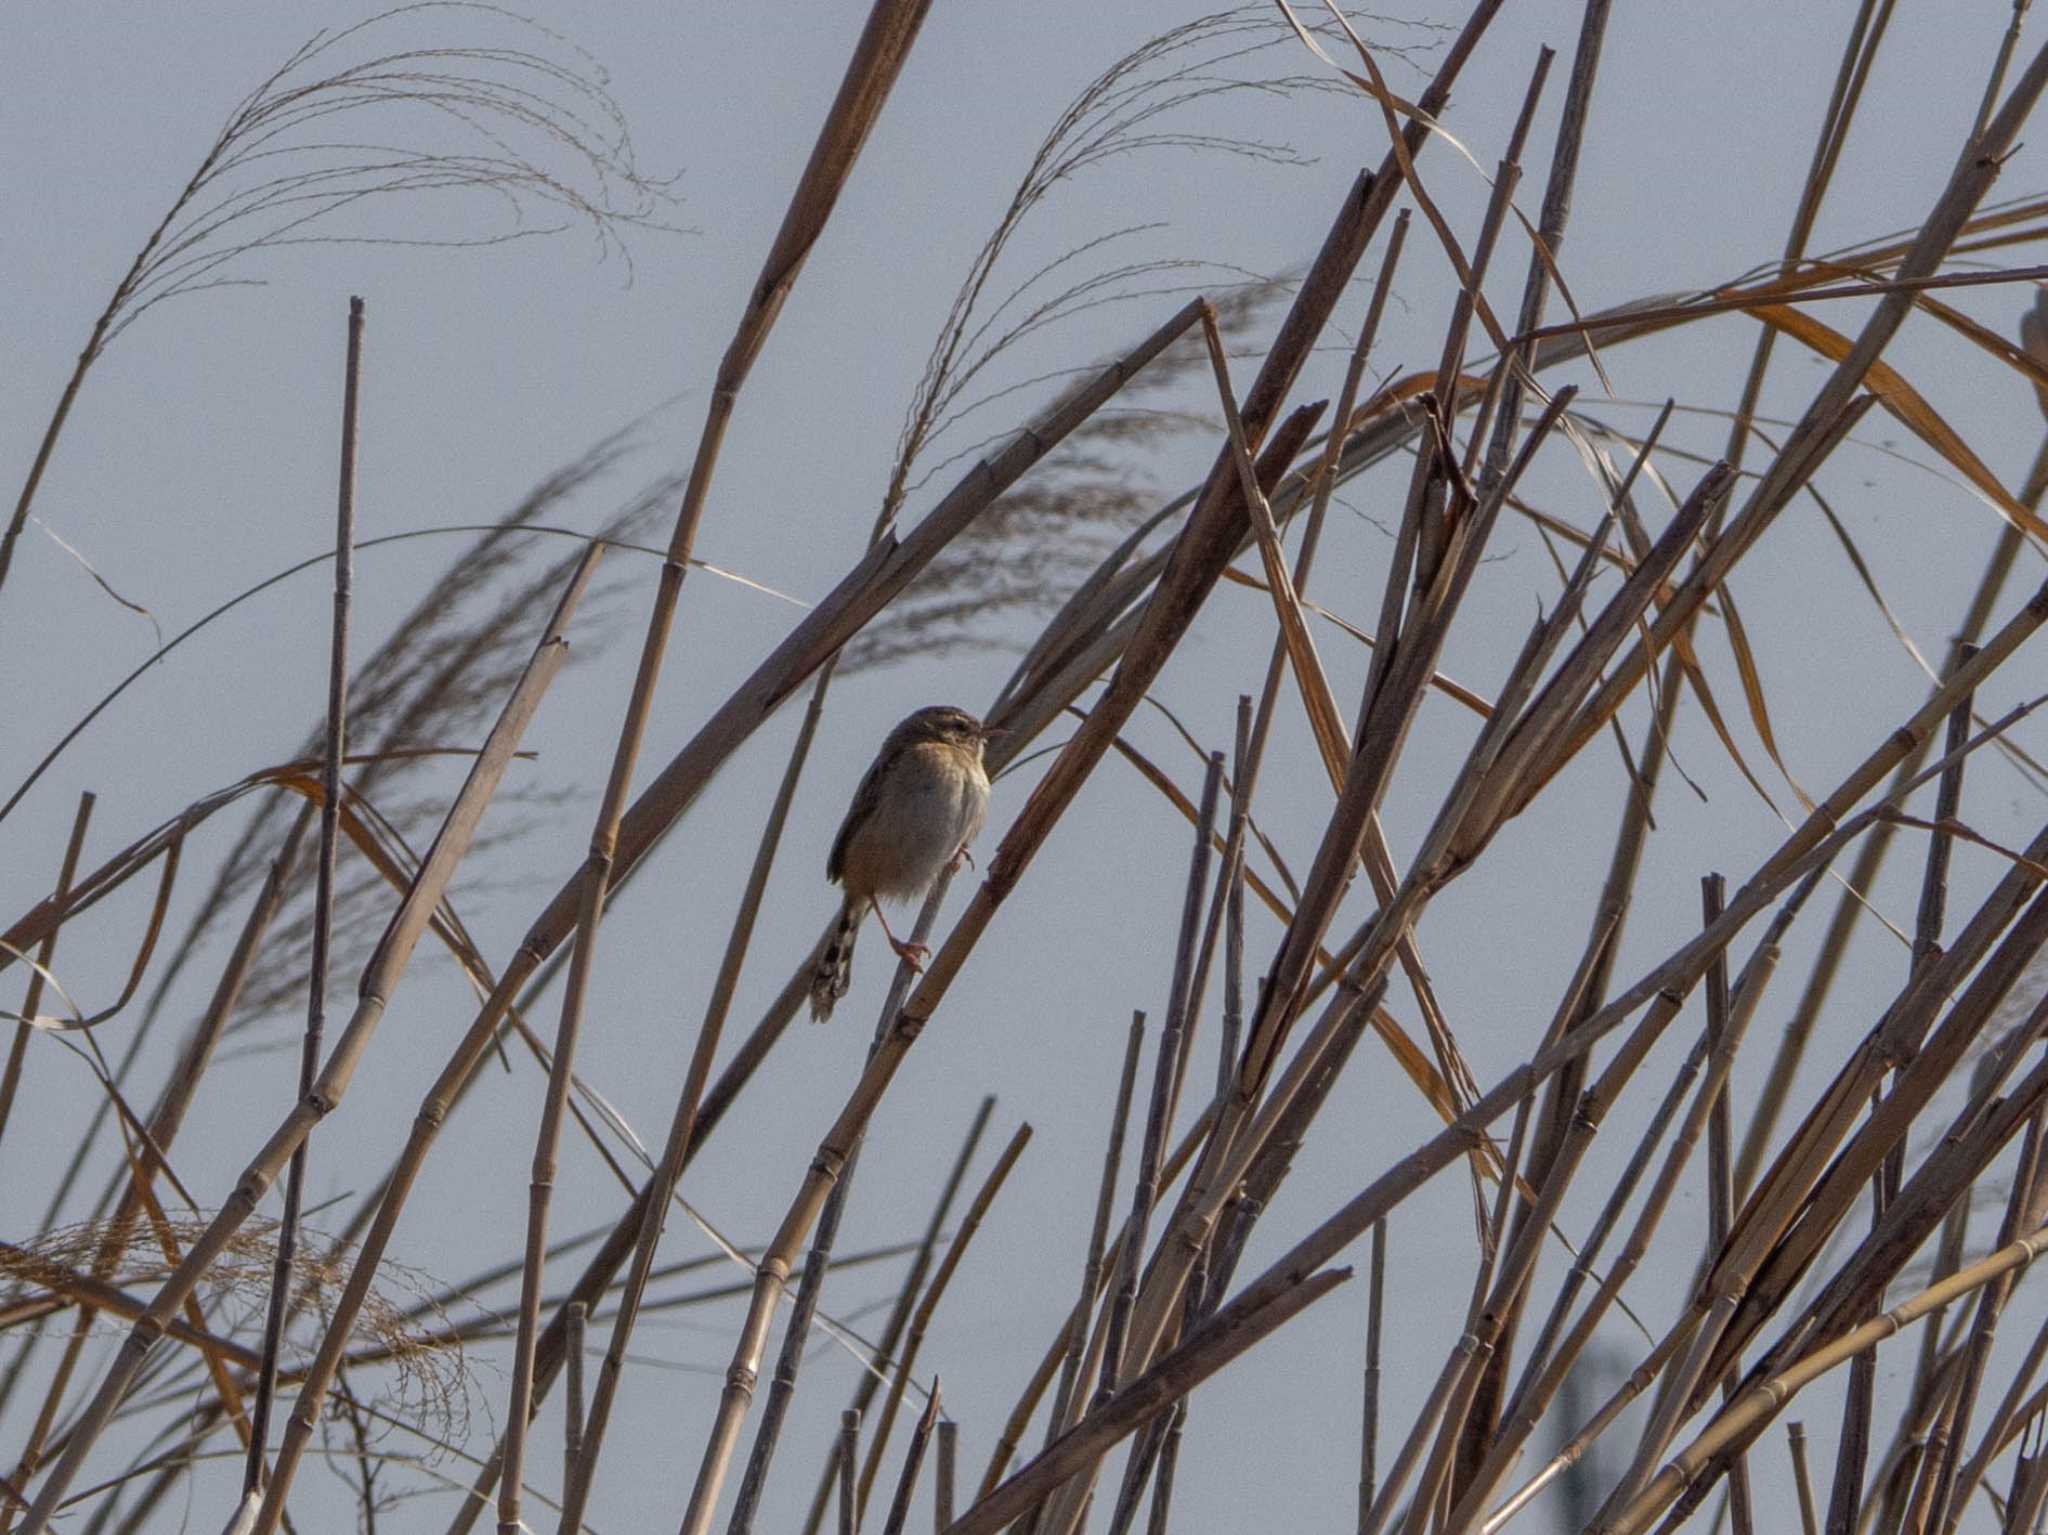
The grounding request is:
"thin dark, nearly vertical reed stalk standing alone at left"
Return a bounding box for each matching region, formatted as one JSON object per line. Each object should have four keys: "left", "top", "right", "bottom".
{"left": 242, "top": 297, "right": 362, "bottom": 1502}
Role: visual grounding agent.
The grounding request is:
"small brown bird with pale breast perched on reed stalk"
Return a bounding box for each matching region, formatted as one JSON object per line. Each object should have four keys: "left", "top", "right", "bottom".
{"left": 811, "top": 704, "right": 995, "bottom": 1023}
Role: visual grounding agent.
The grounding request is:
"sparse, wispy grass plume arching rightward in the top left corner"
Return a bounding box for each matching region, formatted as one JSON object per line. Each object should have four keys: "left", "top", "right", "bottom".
{"left": 0, "top": 0, "right": 676, "bottom": 601}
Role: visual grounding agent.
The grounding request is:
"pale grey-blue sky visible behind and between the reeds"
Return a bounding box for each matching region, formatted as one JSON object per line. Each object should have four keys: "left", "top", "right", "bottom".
{"left": 12, "top": 0, "right": 2044, "bottom": 1535}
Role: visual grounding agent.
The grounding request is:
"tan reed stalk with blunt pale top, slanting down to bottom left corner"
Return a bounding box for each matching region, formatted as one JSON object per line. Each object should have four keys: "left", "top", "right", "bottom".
{"left": 23, "top": 549, "right": 598, "bottom": 1535}
